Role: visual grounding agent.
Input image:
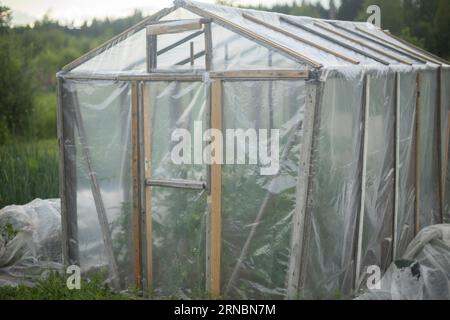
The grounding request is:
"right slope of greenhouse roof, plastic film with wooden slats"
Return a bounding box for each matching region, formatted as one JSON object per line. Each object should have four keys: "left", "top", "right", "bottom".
{"left": 175, "top": 0, "right": 449, "bottom": 67}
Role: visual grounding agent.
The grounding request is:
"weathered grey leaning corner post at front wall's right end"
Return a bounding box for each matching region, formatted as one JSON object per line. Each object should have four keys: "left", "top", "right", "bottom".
{"left": 286, "top": 81, "right": 321, "bottom": 299}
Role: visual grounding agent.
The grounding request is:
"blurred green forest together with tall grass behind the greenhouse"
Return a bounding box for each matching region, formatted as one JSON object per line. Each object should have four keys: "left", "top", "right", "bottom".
{"left": 0, "top": 0, "right": 450, "bottom": 208}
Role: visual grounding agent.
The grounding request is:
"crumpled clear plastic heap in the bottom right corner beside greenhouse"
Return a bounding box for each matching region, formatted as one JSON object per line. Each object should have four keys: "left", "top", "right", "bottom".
{"left": 357, "top": 224, "right": 450, "bottom": 300}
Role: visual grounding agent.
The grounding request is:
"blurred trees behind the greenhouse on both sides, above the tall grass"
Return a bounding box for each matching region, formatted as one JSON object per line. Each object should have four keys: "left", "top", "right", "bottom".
{"left": 0, "top": 0, "right": 450, "bottom": 144}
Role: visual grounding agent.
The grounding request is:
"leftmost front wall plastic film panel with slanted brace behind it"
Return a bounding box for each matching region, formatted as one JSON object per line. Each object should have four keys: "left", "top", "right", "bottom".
{"left": 64, "top": 81, "right": 133, "bottom": 287}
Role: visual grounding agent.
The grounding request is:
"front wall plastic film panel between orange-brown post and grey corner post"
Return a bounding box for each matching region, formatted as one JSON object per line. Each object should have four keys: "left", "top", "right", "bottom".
{"left": 221, "top": 81, "right": 305, "bottom": 299}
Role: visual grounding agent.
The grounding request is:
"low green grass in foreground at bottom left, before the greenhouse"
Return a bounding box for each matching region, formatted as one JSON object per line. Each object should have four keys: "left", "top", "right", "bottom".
{"left": 0, "top": 272, "right": 132, "bottom": 300}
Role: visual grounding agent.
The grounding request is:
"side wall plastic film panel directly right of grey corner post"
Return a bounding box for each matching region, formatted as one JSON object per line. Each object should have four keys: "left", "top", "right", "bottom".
{"left": 301, "top": 73, "right": 363, "bottom": 298}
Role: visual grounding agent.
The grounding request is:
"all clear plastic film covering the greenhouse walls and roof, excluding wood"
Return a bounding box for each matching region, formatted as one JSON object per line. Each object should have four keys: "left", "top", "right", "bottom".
{"left": 60, "top": 1, "right": 450, "bottom": 299}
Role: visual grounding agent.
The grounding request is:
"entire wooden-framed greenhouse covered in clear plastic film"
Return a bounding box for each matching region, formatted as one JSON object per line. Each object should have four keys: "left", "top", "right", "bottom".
{"left": 57, "top": 0, "right": 450, "bottom": 299}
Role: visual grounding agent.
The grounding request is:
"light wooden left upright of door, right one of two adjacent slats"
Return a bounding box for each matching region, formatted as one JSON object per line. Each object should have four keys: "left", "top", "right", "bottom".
{"left": 142, "top": 83, "right": 153, "bottom": 292}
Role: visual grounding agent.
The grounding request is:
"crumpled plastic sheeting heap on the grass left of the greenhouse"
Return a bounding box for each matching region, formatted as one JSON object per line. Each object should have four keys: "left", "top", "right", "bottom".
{"left": 0, "top": 199, "right": 62, "bottom": 286}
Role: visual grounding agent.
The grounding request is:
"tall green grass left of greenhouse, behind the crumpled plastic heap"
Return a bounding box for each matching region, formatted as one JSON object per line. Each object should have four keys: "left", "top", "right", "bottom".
{"left": 0, "top": 140, "right": 59, "bottom": 208}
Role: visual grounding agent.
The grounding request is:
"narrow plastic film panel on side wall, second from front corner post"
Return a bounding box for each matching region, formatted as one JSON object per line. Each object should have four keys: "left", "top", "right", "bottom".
{"left": 361, "top": 73, "right": 395, "bottom": 272}
